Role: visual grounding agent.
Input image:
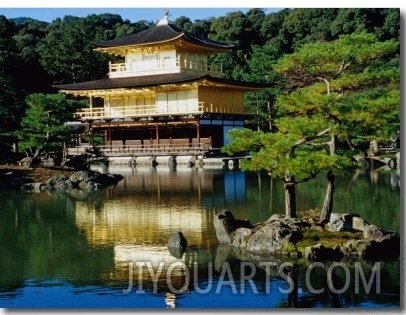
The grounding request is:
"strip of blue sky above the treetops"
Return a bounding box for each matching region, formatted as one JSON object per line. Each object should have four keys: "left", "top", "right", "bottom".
{"left": 0, "top": 5, "right": 282, "bottom": 22}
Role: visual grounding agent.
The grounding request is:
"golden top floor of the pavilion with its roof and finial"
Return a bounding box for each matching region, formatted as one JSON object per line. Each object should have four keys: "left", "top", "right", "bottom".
{"left": 95, "top": 15, "right": 233, "bottom": 78}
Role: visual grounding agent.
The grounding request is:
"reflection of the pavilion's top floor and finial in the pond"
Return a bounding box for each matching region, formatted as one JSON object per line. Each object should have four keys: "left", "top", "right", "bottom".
{"left": 109, "top": 245, "right": 215, "bottom": 302}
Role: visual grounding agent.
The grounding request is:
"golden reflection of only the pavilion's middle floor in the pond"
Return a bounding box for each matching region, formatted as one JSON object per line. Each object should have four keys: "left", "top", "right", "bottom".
{"left": 76, "top": 196, "right": 214, "bottom": 247}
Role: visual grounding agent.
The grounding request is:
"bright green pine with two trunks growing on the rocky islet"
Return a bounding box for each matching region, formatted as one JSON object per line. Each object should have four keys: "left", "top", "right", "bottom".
{"left": 225, "top": 33, "right": 400, "bottom": 222}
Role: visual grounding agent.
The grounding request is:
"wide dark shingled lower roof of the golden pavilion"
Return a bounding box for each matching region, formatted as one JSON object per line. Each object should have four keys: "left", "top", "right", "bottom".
{"left": 54, "top": 73, "right": 269, "bottom": 91}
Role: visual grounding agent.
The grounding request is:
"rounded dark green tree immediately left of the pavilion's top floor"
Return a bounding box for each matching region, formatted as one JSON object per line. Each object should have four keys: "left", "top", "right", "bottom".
{"left": 38, "top": 14, "right": 147, "bottom": 83}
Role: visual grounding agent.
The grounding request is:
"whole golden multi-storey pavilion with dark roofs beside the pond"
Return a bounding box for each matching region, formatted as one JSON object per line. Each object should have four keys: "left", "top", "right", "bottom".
{"left": 57, "top": 12, "right": 264, "bottom": 156}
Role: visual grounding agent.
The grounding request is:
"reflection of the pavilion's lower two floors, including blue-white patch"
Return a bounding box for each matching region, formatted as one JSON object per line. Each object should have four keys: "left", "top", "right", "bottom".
{"left": 75, "top": 168, "right": 245, "bottom": 248}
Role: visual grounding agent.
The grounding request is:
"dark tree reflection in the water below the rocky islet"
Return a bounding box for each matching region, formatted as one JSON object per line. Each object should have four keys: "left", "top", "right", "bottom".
{"left": 228, "top": 247, "right": 400, "bottom": 308}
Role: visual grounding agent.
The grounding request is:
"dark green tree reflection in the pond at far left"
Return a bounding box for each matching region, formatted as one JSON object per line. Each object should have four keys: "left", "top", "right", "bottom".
{"left": 0, "top": 192, "right": 113, "bottom": 291}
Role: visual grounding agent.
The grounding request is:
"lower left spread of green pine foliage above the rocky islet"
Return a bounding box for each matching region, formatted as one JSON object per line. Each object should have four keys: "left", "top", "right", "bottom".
{"left": 223, "top": 128, "right": 350, "bottom": 182}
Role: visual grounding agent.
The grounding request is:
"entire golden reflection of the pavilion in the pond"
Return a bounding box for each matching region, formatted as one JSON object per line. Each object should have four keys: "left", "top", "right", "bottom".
{"left": 75, "top": 167, "right": 245, "bottom": 307}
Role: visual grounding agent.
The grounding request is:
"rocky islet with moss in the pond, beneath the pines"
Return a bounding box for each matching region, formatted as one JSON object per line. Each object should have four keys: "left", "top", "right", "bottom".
{"left": 214, "top": 210, "right": 400, "bottom": 260}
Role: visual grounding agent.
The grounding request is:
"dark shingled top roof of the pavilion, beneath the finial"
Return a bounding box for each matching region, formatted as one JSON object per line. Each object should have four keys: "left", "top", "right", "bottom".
{"left": 95, "top": 24, "right": 234, "bottom": 49}
